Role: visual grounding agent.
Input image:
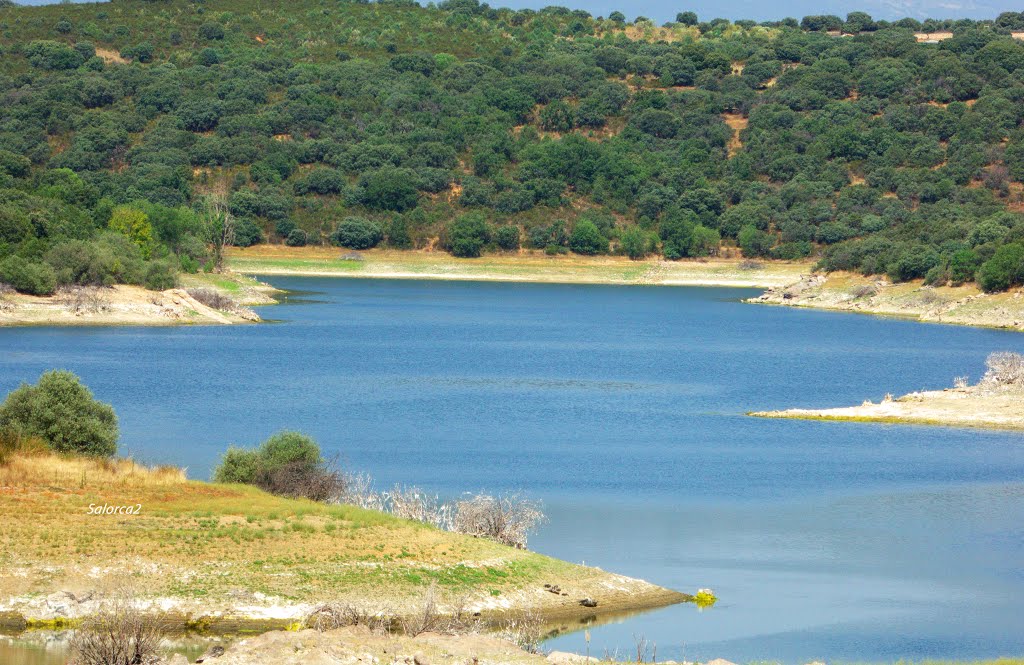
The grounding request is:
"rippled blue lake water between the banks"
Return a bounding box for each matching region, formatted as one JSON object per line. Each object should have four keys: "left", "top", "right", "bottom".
{"left": 0, "top": 278, "right": 1024, "bottom": 663}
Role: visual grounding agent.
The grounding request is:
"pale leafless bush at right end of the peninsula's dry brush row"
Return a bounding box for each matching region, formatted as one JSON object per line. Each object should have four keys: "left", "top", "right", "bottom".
{"left": 453, "top": 494, "right": 546, "bottom": 549}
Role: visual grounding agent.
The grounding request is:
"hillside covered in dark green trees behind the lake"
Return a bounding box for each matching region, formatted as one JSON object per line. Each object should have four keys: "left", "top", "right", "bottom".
{"left": 0, "top": 0, "right": 1024, "bottom": 293}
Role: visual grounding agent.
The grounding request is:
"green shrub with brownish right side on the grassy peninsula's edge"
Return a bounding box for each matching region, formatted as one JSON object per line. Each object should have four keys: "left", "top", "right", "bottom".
{"left": 213, "top": 431, "right": 344, "bottom": 501}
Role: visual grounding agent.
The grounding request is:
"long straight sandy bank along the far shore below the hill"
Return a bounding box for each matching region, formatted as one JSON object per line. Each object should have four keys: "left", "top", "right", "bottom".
{"left": 227, "top": 245, "right": 809, "bottom": 288}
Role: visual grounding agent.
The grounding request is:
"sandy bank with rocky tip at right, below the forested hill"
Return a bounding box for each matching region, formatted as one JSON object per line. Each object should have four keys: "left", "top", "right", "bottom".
{"left": 748, "top": 273, "right": 1024, "bottom": 330}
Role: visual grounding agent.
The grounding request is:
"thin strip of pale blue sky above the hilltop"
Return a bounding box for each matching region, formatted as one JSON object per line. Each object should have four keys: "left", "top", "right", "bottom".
{"left": 9, "top": 0, "right": 1024, "bottom": 24}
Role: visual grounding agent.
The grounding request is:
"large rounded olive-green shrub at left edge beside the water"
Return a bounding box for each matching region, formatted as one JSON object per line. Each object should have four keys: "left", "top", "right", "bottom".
{"left": 0, "top": 370, "right": 118, "bottom": 457}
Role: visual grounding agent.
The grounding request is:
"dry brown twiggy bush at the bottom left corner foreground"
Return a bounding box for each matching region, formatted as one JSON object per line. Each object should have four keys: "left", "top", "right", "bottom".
{"left": 71, "top": 600, "right": 165, "bottom": 665}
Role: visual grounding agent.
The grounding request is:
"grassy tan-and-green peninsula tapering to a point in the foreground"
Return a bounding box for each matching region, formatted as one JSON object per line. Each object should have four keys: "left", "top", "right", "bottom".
{"left": 0, "top": 453, "right": 689, "bottom": 630}
